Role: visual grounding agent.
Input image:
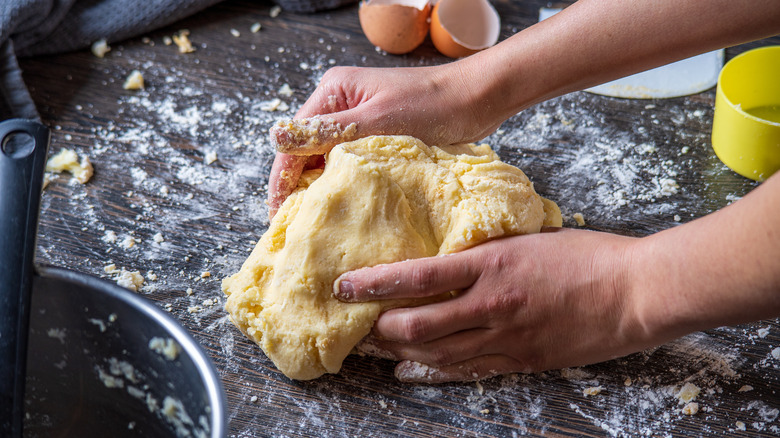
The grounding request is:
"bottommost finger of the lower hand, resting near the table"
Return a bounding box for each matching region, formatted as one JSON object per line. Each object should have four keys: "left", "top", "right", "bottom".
{"left": 395, "top": 354, "right": 530, "bottom": 383}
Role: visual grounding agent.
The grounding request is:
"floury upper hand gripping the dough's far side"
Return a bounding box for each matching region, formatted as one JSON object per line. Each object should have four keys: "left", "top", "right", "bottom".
{"left": 268, "top": 62, "right": 503, "bottom": 216}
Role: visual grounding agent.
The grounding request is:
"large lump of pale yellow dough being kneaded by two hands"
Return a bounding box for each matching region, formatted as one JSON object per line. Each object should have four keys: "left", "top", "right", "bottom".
{"left": 222, "top": 136, "right": 561, "bottom": 380}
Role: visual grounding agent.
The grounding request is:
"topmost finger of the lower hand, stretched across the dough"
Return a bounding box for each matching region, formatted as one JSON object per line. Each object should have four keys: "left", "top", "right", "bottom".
{"left": 333, "top": 253, "right": 479, "bottom": 302}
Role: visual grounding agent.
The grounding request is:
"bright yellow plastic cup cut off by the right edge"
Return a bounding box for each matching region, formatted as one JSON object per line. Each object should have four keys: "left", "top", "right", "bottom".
{"left": 712, "top": 46, "right": 780, "bottom": 181}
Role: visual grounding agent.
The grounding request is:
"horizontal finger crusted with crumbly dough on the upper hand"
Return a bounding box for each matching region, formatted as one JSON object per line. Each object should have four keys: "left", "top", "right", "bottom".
{"left": 269, "top": 116, "right": 357, "bottom": 155}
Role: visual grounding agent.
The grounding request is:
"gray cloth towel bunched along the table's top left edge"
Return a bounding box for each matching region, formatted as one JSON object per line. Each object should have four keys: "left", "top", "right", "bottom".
{"left": 0, "top": 0, "right": 356, "bottom": 120}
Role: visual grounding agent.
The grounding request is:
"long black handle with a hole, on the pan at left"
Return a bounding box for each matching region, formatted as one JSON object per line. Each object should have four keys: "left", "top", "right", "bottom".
{"left": 0, "top": 119, "right": 50, "bottom": 437}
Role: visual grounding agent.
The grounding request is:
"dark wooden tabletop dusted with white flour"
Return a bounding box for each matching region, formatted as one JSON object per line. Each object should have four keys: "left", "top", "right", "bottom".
{"left": 21, "top": 0, "right": 780, "bottom": 437}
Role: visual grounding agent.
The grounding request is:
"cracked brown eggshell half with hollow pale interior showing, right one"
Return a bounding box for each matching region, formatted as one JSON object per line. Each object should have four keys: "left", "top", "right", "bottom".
{"left": 431, "top": 0, "right": 501, "bottom": 58}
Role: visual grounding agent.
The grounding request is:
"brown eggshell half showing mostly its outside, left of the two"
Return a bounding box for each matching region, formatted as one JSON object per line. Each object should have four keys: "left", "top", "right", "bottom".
{"left": 358, "top": 0, "right": 431, "bottom": 55}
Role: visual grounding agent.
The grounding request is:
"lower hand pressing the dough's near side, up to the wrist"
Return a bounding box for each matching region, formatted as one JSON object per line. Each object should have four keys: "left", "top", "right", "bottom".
{"left": 334, "top": 229, "right": 656, "bottom": 383}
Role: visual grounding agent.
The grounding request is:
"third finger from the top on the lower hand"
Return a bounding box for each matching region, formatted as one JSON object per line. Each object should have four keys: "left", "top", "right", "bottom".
{"left": 357, "top": 328, "right": 496, "bottom": 366}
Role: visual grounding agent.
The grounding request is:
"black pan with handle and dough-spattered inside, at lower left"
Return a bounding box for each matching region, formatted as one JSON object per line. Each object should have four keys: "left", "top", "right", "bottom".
{"left": 0, "top": 120, "right": 227, "bottom": 438}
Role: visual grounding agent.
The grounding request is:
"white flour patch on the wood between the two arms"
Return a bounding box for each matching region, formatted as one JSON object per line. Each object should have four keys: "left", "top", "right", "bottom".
{"left": 488, "top": 93, "right": 722, "bottom": 229}
